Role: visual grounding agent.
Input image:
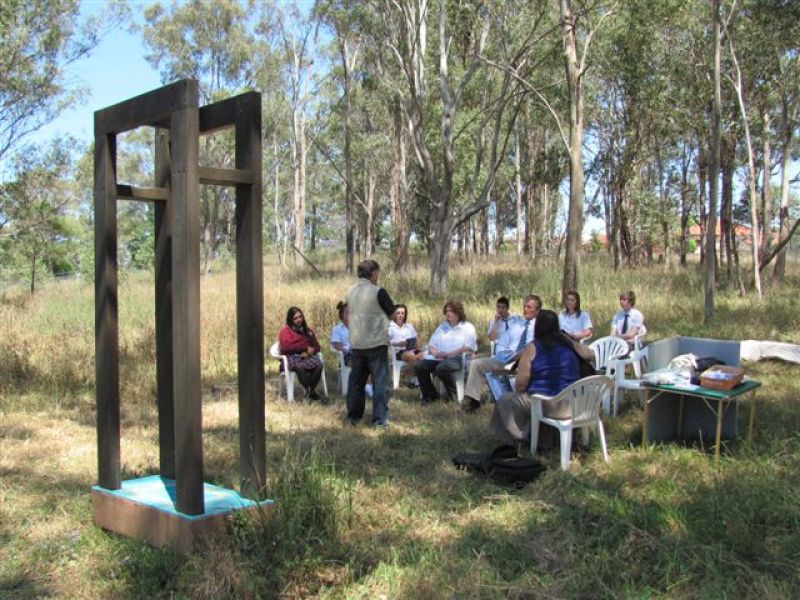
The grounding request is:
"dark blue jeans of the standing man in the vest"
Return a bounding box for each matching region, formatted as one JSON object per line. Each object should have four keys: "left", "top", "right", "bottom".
{"left": 347, "top": 346, "right": 389, "bottom": 425}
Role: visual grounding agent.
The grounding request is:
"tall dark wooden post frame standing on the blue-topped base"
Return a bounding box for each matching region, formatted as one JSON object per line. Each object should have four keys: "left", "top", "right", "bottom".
{"left": 94, "top": 79, "right": 266, "bottom": 515}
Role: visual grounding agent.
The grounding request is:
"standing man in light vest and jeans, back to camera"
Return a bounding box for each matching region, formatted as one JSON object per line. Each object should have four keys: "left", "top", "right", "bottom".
{"left": 345, "top": 259, "right": 396, "bottom": 427}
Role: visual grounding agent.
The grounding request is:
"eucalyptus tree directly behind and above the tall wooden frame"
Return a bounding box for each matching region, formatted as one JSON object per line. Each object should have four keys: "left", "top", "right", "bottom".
{"left": 143, "top": 0, "right": 255, "bottom": 273}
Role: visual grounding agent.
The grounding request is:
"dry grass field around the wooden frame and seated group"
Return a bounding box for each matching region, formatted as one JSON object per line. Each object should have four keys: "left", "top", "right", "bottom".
{"left": 0, "top": 257, "right": 800, "bottom": 599}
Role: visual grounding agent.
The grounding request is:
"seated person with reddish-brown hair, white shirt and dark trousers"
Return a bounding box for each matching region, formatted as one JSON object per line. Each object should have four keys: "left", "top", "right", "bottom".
{"left": 414, "top": 300, "right": 478, "bottom": 404}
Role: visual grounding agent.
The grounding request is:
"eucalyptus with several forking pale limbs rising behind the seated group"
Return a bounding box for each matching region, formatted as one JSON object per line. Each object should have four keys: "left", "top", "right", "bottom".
{"left": 373, "top": 0, "right": 532, "bottom": 295}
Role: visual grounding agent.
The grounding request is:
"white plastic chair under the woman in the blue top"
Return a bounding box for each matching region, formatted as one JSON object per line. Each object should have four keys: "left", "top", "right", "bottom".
{"left": 531, "top": 375, "right": 614, "bottom": 471}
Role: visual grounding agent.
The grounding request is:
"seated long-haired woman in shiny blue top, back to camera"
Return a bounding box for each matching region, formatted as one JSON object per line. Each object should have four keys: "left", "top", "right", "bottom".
{"left": 489, "top": 310, "right": 594, "bottom": 445}
